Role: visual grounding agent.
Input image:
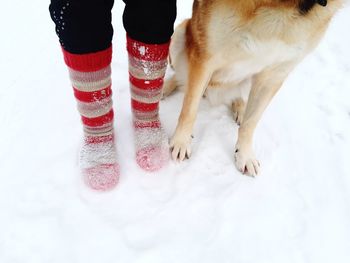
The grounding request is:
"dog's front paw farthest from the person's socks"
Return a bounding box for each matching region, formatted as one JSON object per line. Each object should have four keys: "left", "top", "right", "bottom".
{"left": 235, "top": 148, "right": 260, "bottom": 177}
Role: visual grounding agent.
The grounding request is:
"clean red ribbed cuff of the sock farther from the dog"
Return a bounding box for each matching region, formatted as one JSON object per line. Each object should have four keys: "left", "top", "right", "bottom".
{"left": 62, "top": 46, "right": 112, "bottom": 72}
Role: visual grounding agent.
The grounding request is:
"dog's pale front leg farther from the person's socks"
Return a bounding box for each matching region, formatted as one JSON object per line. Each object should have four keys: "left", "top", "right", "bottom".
{"left": 234, "top": 64, "right": 292, "bottom": 176}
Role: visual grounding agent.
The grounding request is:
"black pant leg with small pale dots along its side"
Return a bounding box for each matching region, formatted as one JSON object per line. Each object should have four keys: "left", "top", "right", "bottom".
{"left": 49, "top": 0, "right": 114, "bottom": 54}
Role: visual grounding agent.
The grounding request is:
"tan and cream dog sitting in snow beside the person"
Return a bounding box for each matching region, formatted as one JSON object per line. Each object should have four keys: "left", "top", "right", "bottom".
{"left": 164, "top": 0, "right": 343, "bottom": 176}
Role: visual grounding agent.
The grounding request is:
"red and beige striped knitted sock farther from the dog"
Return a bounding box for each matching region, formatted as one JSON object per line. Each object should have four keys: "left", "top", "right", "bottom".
{"left": 63, "top": 47, "right": 119, "bottom": 190}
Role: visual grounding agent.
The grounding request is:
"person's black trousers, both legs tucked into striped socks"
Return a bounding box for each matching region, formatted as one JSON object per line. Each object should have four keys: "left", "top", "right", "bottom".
{"left": 49, "top": 0, "right": 176, "bottom": 54}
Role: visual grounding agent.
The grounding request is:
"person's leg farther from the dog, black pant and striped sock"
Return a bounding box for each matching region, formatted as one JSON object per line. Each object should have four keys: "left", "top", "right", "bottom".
{"left": 49, "top": 0, "right": 119, "bottom": 190}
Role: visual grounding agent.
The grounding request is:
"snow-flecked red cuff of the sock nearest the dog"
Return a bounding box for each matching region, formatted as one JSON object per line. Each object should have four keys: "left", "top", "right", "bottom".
{"left": 126, "top": 35, "right": 170, "bottom": 61}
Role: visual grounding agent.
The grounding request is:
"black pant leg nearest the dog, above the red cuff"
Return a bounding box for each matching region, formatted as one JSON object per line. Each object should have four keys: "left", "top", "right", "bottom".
{"left": 123, "top": 0, "right": 176, "bottom": 44}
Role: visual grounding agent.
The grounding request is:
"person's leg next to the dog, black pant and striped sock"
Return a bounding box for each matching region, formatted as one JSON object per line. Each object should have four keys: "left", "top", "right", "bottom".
{"left": 123, "top": 0, "right": 176, "bottom": 171}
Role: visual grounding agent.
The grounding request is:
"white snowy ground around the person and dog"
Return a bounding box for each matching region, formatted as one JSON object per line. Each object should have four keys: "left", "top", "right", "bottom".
{"left": 0, "top": 0, "right": 350, "bottom": 263}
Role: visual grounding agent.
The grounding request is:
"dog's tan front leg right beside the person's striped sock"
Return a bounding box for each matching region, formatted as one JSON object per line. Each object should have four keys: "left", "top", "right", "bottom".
{"left": 170, "top": 62, "right": 211, "bottom": 161}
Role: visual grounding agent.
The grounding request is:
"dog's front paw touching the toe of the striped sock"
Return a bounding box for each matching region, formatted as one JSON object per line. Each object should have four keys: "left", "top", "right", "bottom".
{"left": 170, "top": 135, "right": 192, "bottom": 162}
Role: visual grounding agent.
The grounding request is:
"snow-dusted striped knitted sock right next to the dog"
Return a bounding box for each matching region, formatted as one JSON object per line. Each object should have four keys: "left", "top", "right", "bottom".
{"left": 127, "top": 37, "right": 169, "bottom": 171}
